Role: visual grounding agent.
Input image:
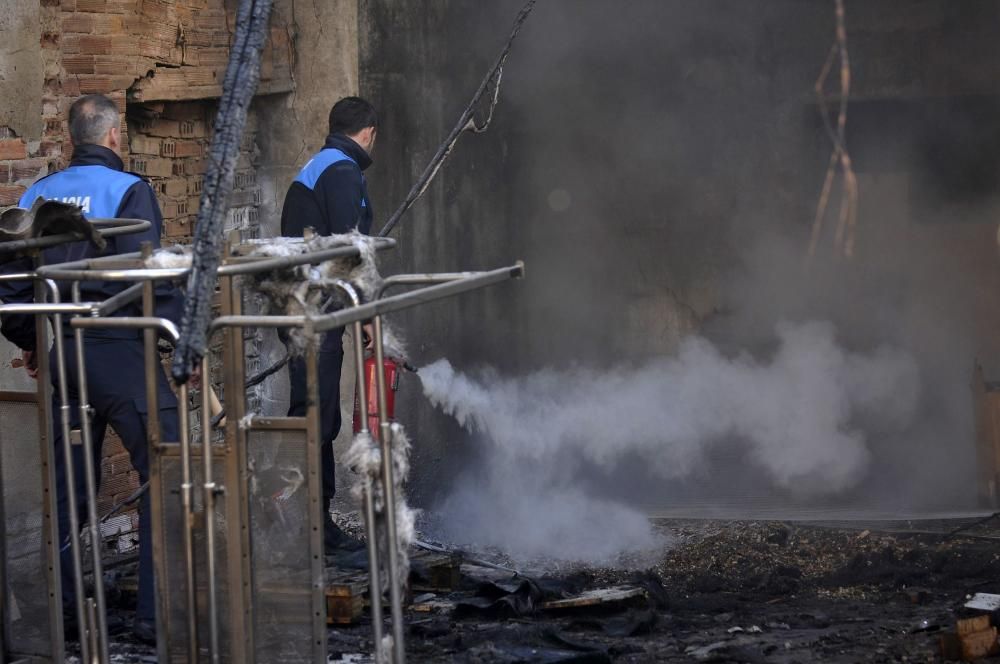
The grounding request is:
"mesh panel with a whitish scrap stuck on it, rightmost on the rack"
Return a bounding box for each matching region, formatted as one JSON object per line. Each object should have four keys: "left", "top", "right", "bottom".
{"left": 247, "top": 431, "right": 313, "bottom": 664}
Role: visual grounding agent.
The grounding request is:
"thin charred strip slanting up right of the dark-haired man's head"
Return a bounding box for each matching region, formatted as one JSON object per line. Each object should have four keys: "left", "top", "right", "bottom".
{"left": 379, "top": 0, "right": 537, "bottom": 237}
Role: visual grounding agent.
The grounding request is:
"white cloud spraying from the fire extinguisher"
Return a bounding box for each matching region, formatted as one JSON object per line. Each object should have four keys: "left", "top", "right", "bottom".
{"left": 419, "top": 322, "right": 920, "bottom": 560}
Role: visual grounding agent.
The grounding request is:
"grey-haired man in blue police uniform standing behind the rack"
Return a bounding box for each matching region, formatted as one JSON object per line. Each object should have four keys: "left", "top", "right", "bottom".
{"left": 0, "top": 95, "right": 183, "bottom": 642}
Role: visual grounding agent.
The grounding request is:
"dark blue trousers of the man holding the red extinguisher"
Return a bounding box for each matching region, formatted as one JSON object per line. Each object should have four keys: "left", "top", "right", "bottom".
{"left": 288, "top": 328, "right": 344, "bottom": 508}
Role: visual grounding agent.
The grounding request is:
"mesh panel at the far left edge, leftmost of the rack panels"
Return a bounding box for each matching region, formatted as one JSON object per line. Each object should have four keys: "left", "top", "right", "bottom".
{"left": 0, "top": 401, "right": 52, "bottom": 656}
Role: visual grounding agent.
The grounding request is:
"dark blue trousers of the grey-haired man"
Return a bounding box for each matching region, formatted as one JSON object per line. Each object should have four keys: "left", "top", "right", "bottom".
{"left": 50, "top": 336, "right": 179, "bottom": 620}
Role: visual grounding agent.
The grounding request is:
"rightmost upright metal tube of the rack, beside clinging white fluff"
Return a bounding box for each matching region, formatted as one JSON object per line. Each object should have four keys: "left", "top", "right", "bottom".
{"left": 374, "top": 316, "right": 406, "bottom": 664}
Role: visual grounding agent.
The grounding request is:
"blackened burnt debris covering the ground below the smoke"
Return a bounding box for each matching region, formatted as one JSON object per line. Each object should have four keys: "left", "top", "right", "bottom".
{"left": 88, "top": 521, "right": 1000, "bottom": 663}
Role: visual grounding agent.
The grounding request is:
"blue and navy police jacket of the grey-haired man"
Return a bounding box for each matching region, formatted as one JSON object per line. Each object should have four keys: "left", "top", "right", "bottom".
{"left": 0, "top": 145, "right": 184, "bottom": 350}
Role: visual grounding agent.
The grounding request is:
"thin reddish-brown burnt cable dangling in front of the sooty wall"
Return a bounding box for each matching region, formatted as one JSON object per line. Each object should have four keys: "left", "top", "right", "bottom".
{"left": 807, "top": 0, "right": 858, "bottom": 259}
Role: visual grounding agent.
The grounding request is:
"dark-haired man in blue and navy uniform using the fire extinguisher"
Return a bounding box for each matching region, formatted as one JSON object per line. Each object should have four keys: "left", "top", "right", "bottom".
{"left": 281, "top": 97, "right": 378, "bottom": 554}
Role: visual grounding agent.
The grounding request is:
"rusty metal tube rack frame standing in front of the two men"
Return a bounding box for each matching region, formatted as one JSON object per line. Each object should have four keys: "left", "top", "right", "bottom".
{"left": 25, "top": 231, "right": 523, "bottom": 663}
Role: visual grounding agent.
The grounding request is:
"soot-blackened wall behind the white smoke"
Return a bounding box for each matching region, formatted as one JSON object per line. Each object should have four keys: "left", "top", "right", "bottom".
{"left": 359, "top": 0, "right": 1000, "bottom": 505}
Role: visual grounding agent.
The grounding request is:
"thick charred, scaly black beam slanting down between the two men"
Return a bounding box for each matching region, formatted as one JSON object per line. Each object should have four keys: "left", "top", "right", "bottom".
{"left": 172, "top": 0, "right": 272, "bottom": 384}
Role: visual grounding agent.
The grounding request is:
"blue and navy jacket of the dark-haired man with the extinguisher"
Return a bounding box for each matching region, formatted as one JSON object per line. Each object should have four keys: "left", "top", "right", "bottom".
{"left": 281, "top": 134, "right": 372, "bottom": 237}
